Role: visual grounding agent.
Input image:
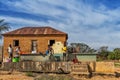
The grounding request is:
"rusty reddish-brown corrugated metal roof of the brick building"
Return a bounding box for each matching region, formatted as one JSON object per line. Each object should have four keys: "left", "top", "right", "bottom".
{"left": 3, "top": 26, "right": 67, "bottom": 35}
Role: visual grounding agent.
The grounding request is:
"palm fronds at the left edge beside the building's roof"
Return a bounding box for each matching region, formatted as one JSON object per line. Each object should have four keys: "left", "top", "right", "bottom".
{"left": 0, "top": 19, "right": 10, "bottom": 38}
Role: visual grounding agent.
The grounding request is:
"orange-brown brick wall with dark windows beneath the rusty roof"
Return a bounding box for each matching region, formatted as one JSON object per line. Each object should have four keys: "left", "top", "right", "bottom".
{"left": 3, "top": 35, "right": 66, "bottom": 56}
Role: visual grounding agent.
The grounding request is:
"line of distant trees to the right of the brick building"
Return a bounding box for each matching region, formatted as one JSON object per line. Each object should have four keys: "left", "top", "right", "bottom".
{"left": 68, "top": 43, "right": 120, "bottom": 60}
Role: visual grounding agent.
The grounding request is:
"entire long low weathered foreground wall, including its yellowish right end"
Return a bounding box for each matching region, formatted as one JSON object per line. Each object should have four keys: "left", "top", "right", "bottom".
{"left": 2, "top": 61, "right": 115, "bottom": 74}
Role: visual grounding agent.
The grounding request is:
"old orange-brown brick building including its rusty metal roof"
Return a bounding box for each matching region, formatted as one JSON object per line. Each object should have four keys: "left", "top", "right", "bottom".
{"left": 3, "top": 27, "right": 68, "bottom": 56}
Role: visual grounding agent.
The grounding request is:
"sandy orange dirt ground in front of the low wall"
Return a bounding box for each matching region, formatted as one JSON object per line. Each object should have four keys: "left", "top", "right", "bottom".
{"left": 0, "top": 68, "right": 120, "bottom": 80}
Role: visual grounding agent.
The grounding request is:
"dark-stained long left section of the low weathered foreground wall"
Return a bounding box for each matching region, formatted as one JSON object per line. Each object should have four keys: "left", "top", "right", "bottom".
{"left": 2, "top": 61, "right": 71, "bottom": 72}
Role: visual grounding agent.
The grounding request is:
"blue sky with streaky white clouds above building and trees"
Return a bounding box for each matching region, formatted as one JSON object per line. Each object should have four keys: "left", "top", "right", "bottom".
{"left": 0, "top": 0, "right": 120, "bottom": 49}
